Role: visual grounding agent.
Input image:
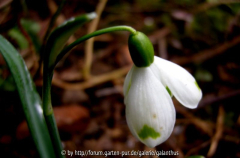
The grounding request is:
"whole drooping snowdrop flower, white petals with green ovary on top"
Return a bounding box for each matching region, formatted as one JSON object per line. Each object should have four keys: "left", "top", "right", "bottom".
{"left": 124, "top": 32, "right": 202, "bottom": 147}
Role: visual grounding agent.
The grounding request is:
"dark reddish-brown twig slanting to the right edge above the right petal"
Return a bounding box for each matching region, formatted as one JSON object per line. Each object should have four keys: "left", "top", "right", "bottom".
{"left": 172, "top": 36, "right": 240, "bottom": 65}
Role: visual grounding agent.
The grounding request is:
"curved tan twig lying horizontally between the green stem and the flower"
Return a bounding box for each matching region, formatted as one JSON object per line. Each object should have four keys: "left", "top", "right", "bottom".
{"left": 52, "top": 66, "right": 131, "bottom": 90}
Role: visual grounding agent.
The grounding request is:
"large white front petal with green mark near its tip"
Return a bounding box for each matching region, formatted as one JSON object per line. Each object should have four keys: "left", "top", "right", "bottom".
{"left": 125, "top": 66, "right": 176, "bottom": 147}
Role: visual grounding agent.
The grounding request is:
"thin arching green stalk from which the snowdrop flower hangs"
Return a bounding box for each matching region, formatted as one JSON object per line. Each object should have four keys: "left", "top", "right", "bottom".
{"left": 54, "top": 26, "right": 136, "bottom": 66}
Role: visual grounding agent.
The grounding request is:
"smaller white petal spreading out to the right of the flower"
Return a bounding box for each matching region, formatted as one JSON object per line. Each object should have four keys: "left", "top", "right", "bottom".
{"left": 152, "top": 56, "right": 202, "bottom": 109}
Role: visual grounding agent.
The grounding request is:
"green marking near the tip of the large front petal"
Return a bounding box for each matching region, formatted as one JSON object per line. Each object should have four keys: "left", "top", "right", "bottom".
{"left": 138, "top": 125, "right": 161, "bottom": 140}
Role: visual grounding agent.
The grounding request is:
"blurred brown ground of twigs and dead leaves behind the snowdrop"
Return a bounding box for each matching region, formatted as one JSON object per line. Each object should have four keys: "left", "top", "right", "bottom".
{"left": 0, "top": 0, "right": 240, "bottom": 158}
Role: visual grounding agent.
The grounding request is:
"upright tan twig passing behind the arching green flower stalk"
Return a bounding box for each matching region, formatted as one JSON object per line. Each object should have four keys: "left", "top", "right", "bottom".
{"left": 83, "top": 0, "right": 107, "bottom": 79}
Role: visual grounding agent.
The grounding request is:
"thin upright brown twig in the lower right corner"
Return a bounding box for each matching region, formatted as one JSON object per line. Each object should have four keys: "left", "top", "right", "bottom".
{"left": 207, "top": 106, "right": 224, "bottom": 157}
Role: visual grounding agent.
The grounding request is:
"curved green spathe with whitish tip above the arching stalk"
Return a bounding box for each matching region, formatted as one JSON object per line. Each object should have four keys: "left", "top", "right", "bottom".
{"left": 44, "top": 13, "right": 96, "bottom": 69}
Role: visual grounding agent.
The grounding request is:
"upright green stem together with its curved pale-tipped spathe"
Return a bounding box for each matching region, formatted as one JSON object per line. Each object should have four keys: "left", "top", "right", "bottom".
{"left": 42, "top": 13, "right": 96, "bottom": 158}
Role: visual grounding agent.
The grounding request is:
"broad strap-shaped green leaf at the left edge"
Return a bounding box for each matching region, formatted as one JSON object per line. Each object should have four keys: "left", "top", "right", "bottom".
{"left": 0, "top": 35, "right": 55, "bottom": 158}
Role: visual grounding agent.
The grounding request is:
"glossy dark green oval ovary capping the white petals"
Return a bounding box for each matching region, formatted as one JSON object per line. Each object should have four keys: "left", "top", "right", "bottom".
{"left": 128, "top": 32, "right": 154, "bottom": 67}
